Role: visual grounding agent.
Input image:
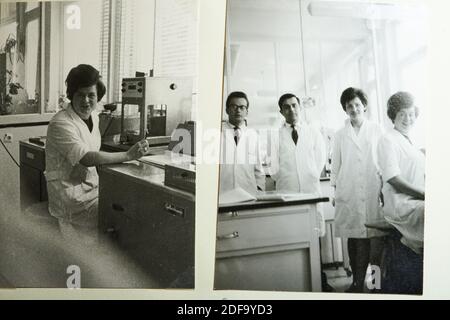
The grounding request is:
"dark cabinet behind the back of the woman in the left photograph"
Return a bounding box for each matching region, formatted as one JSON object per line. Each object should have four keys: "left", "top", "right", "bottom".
{"left": 19, "top": 141, "right": 48, "bottom": 211}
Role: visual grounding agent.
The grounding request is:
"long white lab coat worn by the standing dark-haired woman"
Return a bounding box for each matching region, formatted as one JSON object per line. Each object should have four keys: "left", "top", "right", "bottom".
{"left": 330, "top": 119, "right": 384, "bottom": 238}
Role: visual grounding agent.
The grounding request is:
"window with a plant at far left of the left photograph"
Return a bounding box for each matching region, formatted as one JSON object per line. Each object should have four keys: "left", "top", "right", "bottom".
{"left": 0, "top": 2, "right": 46, "bottom": 116}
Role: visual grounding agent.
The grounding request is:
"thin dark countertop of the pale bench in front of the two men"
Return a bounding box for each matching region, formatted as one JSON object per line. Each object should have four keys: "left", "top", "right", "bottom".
{"left": 219, "top": 196, "right": 330, "bottom": 213}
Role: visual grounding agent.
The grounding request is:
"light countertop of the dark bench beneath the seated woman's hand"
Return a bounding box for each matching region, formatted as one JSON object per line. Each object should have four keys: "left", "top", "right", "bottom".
{"left": 98, "top": 161, "right": 195, "bottom": 201}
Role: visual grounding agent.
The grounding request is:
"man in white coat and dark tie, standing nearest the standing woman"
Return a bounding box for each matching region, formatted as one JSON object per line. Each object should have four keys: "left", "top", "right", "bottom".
{"left": 270, "top": 93, "right": 334, "bottom": 292}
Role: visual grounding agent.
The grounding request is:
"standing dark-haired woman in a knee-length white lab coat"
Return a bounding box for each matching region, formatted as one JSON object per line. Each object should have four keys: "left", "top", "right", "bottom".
{"left": 331, "top": 87, "right": 384, "bottom": 292}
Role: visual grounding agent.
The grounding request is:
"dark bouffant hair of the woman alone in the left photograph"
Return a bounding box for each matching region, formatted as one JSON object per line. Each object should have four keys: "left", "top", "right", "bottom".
{"left": 66, "top": 64, "right": 106, "bottom": 101}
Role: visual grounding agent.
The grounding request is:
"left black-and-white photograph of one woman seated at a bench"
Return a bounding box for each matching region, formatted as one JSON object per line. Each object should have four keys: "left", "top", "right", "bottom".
{"left": 0, "top": 0, "right": 198, "bottom": 289}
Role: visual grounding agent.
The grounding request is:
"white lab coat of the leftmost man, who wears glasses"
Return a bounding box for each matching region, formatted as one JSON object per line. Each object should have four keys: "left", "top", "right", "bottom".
{"left": 219, "top": 122, "right": 265, "bottom": 195}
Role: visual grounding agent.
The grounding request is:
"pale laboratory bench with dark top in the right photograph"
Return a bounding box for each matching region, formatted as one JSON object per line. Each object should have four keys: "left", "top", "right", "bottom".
{"left": 214, "top": 195, "right": 329, "bottom": 292}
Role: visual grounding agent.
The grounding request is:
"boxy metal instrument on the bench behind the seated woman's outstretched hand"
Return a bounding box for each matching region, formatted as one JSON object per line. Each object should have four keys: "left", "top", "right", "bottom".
{"left": 120, "top": 77, "right": 192, "bottom": 145}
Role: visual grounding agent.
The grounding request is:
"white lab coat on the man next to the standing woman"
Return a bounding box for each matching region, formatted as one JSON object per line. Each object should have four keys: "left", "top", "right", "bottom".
{"left": 268, "top": 123, "right": 326, "bottom": 236}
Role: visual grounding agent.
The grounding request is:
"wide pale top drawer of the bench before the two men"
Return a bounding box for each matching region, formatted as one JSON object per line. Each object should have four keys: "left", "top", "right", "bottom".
{"left": 216, "top": 208, "right": 315, "bottom": 252}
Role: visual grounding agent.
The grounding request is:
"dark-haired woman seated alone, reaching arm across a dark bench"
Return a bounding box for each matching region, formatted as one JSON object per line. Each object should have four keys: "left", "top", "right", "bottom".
{"left": 45, "top": 64, "right": 148, "bottom": 243}
